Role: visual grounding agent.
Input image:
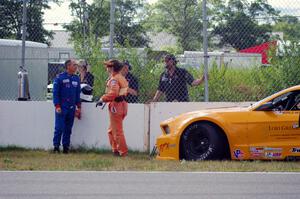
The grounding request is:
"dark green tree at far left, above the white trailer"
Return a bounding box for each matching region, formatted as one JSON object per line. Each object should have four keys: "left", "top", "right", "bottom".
{"left": 0, "top": 0, "right": 59, "bottom": 43}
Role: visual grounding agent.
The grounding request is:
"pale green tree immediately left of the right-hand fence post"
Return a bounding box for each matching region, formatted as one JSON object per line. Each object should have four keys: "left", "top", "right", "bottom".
{"left": 147, "top": 0, "right": 202, "bottom": 50}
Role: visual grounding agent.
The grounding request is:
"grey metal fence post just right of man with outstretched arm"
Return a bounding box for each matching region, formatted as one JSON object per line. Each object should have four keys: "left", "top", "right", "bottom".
{"left": 202, "top": 0, "right": 209, "bottom": 102}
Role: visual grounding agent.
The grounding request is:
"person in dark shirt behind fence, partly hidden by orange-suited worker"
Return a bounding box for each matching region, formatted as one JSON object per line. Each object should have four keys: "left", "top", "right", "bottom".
{"left": 122, "top": 60, "right": 139, "bottom": 103}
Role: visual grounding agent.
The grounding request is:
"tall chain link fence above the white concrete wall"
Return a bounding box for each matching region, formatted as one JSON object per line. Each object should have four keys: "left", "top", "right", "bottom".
{"left": 0, "top": 0, "right": 300, "bottom": 103}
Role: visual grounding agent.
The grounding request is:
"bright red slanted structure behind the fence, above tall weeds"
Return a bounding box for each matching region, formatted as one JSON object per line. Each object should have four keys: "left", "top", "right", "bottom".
{"left": 240, "top": 41, "right": 277, "bottom": 64}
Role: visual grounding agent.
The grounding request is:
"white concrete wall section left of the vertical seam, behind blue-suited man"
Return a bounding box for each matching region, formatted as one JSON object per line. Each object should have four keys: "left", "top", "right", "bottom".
{"left": 0, "top": 101, "right": 148, "bottom": 151}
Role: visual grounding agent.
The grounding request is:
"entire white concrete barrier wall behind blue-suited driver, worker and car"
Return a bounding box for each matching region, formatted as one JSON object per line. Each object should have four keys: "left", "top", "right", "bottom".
{"left": 0, "top": 101, "right": 250, "bottom": 151}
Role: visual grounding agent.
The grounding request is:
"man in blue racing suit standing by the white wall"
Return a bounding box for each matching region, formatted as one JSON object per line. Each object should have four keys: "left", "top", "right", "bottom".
{"left": 53, "top": 59, "right": 81, "bottom": 153}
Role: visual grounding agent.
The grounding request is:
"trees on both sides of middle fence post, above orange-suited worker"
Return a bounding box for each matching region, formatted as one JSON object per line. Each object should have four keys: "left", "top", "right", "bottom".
{"left": 65, "top": 0, "right": 149, "bottom": 47}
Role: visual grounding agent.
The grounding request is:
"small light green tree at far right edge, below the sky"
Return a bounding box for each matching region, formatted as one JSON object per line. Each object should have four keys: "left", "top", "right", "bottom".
{"left": 273, "top": 15, "right": 300, "bottom": 41}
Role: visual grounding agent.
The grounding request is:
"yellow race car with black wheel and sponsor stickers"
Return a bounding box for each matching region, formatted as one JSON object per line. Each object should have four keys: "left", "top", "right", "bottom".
{"left": 156, "top": 85, "right": 300, "bottom": 160}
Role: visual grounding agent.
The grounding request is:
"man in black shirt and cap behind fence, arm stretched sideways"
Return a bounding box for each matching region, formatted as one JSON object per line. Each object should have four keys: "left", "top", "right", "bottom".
{"left": 152, "top": 54, "right": 204, "bottom": 102}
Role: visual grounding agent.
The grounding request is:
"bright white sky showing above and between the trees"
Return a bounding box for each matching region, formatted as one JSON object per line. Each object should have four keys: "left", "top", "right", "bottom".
{"left": 44, "top": 0, "right": 300, "bottom": 30}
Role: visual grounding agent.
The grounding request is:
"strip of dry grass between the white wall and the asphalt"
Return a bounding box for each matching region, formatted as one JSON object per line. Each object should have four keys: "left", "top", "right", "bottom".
{"left": 0, "top": 147, "right": 300, "bottom": 172}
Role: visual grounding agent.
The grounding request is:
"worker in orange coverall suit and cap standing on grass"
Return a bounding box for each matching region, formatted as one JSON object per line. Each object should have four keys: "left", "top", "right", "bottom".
{"left": 96, "top": 59, "right": 128, "bottom": 157}
